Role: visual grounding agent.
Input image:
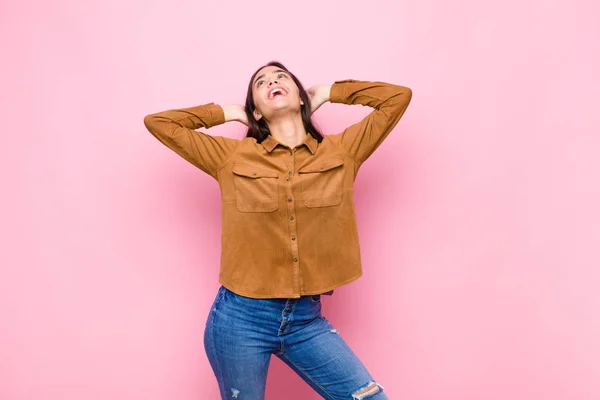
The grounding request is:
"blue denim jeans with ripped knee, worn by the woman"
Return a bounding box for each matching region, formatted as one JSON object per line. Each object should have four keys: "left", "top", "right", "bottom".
{"left": 204, "top": 286, "right": 387, "bottom": 400}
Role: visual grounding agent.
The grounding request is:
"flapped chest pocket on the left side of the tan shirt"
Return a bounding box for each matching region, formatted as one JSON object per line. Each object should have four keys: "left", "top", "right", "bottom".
{"left": 232, "top": 163, "right": 279, "bottom": 212}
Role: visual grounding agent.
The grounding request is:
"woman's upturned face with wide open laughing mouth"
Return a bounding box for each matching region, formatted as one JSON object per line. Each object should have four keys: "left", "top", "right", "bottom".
{"left": 252, "top": 66, "right": 303, "bottom": 121}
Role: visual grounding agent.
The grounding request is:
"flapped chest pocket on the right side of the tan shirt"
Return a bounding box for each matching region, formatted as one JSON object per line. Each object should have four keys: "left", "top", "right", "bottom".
{"left": 298, "top": 156, "right": 344, "bottom": 207}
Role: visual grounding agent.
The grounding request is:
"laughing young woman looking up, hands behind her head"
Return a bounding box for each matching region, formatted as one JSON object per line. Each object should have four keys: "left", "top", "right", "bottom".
{"left": 144, "top": 62, "right": 412, "bottom": 400}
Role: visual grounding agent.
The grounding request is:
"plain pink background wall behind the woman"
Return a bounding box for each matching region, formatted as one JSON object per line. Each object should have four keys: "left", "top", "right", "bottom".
{"left": 0, "top": 0, "right": 600, "bottom": 400}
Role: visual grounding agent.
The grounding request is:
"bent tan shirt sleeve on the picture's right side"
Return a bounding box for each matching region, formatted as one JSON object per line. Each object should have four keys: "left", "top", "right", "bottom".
{"left": 329, "top": 79, "right": 412, "bottom": 163}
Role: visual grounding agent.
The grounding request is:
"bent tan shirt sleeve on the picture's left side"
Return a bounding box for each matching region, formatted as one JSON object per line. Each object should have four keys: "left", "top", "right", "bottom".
{"left": 144, "top": 103, "right": 241, "bottom": 179}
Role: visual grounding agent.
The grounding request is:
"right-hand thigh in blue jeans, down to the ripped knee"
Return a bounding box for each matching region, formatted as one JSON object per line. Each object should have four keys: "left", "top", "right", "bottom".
{"left": 274, "top": 316, "right": 387, "bottom": 400}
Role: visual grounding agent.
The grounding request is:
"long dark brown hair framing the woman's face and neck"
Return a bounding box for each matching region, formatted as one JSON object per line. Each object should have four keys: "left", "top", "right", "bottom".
{"left": 246, "top": 61, "right": 323, "bottom": 143}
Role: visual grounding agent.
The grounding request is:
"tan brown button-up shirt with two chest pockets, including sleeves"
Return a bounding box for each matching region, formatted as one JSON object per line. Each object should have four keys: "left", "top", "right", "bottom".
{"left": 144, "top": 79, "right": 412, "bottom": 298}
